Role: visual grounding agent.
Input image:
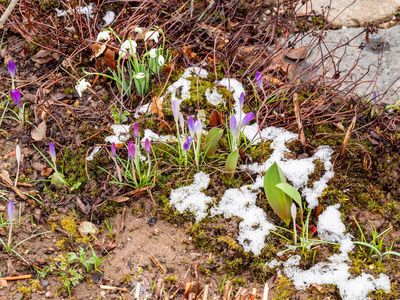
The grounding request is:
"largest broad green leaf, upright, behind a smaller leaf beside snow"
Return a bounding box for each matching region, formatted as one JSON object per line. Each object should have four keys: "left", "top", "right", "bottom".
{"left": 264, "top": 162, "right": 292, "bottom": 225}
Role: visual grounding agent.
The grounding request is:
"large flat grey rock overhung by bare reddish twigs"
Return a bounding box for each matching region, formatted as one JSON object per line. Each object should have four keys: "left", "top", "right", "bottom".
{"left": 291, "top": 26, "right": 400, "bottom": 105}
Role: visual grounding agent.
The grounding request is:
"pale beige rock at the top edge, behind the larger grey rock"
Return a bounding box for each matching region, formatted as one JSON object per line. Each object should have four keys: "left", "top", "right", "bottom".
{"left": 297, "top": 0, "right": 400, "bottom": 27}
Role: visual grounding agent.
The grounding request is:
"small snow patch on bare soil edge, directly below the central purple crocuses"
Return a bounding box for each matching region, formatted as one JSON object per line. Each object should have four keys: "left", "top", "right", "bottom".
{"left": 170, "top": 172, "right": 212, "bottom": 221}
